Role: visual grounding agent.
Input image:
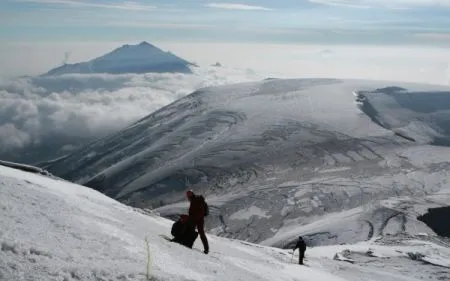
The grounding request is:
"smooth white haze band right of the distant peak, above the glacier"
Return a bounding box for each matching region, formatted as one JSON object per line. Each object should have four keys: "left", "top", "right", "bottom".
{"left": 160, "top": 40, "right": 450, "bottom": 85}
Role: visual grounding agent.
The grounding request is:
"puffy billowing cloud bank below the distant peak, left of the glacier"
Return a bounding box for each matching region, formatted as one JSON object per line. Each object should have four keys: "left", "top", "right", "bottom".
{"left": 0, "top": 68, "right": 263, "bottom": 154}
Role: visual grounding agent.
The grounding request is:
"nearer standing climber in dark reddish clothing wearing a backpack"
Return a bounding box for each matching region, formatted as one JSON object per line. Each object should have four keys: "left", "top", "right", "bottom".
{"left": 186, "top": 190, "right": 209, "bottom": 254}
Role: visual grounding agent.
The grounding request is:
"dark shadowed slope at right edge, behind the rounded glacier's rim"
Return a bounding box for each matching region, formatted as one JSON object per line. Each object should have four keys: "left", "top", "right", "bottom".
{"left": 355, "top": 87, "right": 450, "bottom": 146}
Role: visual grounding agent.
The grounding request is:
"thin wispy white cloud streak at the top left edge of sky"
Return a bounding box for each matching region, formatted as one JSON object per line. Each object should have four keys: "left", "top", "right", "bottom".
{"left": 19, "top": 0, "right": 156, "bottom": 11}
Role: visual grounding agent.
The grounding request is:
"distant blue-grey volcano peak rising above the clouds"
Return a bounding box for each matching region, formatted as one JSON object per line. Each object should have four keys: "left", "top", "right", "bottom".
{"left": 45, "top": 42, "right": 192, "bottom": 75}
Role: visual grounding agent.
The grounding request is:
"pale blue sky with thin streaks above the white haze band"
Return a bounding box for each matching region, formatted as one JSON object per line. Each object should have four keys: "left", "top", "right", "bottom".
{"left": 0, "top": 0, "right": 450, "bottom": 45}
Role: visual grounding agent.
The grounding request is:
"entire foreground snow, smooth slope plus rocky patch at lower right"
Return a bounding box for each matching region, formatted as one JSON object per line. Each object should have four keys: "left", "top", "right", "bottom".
{"left": 0, "top": 166, "right": 450, "bottom": 281}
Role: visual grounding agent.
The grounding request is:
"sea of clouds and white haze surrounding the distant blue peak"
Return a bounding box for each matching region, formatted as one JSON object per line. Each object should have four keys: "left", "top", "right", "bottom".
{"left": 0, "top": 42, "right": 450, "bottom": 162}
